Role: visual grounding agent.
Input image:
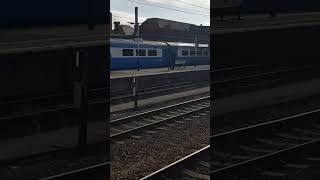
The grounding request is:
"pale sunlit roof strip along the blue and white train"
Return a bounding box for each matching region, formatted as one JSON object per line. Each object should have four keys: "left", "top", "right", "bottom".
{"left": 110, "top": 38, "right": 208, "bottom": 47}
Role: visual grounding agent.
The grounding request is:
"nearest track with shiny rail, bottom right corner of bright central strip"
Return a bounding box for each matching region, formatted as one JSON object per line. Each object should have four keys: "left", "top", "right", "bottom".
{"left": 140, "top": 145, "right": 210, "bottom": 180}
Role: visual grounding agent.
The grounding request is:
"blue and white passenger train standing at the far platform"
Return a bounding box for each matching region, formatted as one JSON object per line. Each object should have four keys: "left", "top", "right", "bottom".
{"left": 110, "top": 39, "right": 210, "bottom": 70}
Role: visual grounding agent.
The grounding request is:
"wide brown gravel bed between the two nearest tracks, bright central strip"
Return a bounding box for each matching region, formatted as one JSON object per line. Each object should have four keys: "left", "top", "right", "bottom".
{"left": 111, "top": 111, "right": 210, "bottom": 179}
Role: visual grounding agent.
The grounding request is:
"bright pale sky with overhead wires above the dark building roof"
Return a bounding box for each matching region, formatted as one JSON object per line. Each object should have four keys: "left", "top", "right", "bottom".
{"left": 110, "top": 0, "right": 210, "bottom": 26}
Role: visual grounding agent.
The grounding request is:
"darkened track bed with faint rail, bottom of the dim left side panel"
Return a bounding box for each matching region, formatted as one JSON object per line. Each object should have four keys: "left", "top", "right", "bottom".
{"left": 0, "top": 143, "right": 110, "bottom": 180}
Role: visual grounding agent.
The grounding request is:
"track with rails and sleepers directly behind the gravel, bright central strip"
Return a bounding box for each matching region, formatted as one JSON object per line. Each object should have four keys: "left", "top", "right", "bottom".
{"left": 110, "top": 96, "right": 210, "bottom": 140}
